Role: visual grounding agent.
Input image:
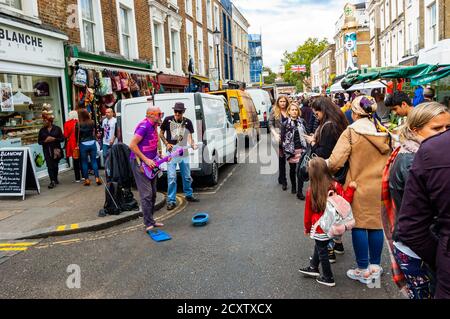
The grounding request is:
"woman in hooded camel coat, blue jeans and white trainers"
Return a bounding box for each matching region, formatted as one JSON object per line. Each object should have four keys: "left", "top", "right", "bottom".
{"left": 328, "top": 96, "right": 391, "bottom": 283}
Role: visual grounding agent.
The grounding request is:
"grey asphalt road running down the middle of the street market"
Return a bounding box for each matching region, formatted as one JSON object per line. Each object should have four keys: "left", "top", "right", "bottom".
{"left": 0, "top": 138, "right": 401, "bottom": 299}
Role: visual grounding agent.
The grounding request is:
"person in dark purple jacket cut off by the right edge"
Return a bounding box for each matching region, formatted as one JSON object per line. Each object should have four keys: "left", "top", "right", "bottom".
{"left": 397, "top": 130, "right": 450, "bottom": 299}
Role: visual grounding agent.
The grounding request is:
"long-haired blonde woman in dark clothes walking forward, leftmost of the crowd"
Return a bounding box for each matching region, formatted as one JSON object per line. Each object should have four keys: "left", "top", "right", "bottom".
{"left": 269, "top": 95, "right": 290, "bottom": 190}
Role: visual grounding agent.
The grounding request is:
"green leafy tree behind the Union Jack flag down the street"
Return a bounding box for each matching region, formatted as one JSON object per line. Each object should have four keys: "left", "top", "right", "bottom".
{"left": 281, "top": 38, "right": 329, "bottom": 91}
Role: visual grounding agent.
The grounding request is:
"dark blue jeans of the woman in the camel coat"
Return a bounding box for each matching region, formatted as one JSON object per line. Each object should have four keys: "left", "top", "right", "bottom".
{"left": 352, "top": 228, "right": 384, "bottom": 269}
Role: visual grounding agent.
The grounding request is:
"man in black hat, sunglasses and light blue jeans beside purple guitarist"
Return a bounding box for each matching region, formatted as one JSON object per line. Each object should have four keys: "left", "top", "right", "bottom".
{"left": 159, "top": 102, "right": 199, "bottom": 210}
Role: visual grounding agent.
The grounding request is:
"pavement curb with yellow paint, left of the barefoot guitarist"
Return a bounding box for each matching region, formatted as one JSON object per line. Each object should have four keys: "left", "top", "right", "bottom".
{"left": 0, "top": 193, "right": 166, "bottom": 240}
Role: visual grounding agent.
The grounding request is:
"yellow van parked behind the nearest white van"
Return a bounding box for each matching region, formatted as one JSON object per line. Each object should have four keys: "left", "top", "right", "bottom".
{"left": 210, "top": 90, "right": 260, "bottom": 143}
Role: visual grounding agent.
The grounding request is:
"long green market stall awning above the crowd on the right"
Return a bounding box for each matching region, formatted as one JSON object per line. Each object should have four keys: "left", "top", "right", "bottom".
{"left": 341, "top": 64, "right": 440, "bottom": 89}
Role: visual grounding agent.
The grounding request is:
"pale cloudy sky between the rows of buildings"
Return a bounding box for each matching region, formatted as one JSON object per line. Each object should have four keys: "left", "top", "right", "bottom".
{"left": 233, "top": 0, "right": 358, "bottom": 72}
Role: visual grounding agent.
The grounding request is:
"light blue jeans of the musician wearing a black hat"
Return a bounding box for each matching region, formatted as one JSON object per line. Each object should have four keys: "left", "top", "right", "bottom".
{"left": 167, "top": 157, "right": 194, "bottom": 204}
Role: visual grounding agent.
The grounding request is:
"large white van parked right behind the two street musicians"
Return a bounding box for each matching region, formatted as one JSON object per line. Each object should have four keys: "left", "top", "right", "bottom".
{"left": 116, "top": 93, "right": 238, "bottom": 185}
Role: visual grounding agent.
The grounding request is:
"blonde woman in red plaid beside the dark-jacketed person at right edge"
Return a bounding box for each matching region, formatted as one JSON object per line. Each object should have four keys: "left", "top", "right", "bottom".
{"left": 381, "top": 102, "right": 450, "bottom": 299}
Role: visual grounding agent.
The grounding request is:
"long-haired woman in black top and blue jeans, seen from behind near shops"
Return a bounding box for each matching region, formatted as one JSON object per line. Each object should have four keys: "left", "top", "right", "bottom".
{"left": 79, "top": 109, "right": 102, "bottom": 186}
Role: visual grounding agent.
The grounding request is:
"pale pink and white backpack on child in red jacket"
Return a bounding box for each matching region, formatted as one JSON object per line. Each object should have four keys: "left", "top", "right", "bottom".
{"left": 318, "top": 191, "right": 355, "bottom": 238}
